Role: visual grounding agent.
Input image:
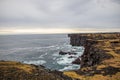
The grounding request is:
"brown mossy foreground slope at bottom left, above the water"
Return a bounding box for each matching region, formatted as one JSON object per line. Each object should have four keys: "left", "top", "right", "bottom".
{"left": 0, "top": 61, "right": 72, "bottom": 80}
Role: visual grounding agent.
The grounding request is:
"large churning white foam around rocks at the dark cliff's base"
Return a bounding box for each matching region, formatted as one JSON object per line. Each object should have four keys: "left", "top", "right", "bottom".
{"left": 56, "top": 46, "right": 84, "bottom": 71}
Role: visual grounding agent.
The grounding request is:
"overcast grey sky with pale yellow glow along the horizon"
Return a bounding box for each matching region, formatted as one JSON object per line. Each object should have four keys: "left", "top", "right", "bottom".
{"left": 0, "top": 0, "right": 120, "bottom": 34}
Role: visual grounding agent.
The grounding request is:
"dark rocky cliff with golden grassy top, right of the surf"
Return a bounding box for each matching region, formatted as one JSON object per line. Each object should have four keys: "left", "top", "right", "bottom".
{"left": 64, "top": 33, "right": 120, "bottom": 80}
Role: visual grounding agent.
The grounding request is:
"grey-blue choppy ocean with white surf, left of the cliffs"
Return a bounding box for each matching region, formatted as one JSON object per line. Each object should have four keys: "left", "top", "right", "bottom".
{"left": 0, "top": 34, "right": 84, "bottom": 71}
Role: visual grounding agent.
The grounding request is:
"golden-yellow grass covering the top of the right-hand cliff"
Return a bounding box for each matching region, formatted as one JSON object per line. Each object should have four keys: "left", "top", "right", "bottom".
{"left": 64, "top": 35, "right": 120, "bottom": 80}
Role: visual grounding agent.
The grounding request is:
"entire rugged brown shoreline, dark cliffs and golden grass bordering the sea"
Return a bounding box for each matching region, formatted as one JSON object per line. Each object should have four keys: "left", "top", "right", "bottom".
{"left": 0, "top": 33, "right": 120, "bottom": 80}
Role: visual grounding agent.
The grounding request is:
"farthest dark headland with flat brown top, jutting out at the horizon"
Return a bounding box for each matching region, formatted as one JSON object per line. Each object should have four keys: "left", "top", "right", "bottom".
{"left": 68, "top": 33, "right": 120, "bottom": 46}
